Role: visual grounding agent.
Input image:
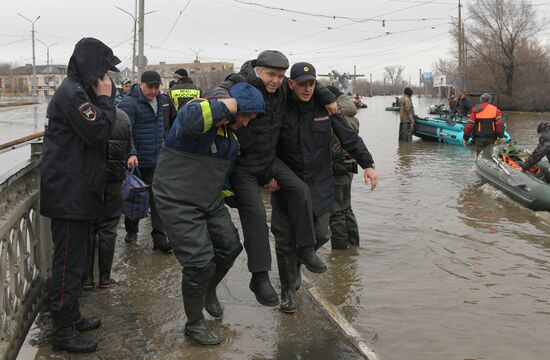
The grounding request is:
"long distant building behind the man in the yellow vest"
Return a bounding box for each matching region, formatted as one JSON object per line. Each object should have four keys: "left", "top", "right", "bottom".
{"left": 145, "top": 60, "right": 234, "bottom": 90}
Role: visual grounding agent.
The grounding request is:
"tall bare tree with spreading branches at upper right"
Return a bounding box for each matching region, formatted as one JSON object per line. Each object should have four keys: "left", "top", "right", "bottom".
{"left": 466, "top": 0, "right": 542, "bottom": 97}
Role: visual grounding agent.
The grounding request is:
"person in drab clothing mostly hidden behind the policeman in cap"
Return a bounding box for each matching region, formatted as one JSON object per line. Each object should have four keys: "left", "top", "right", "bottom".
{"left": 327, "top": 86, "right": 359, "bottom": 250}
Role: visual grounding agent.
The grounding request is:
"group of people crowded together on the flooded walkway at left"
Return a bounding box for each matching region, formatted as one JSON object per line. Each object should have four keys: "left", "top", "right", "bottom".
{"left": 41, "top": 38, "right": 378, "bottom": 352}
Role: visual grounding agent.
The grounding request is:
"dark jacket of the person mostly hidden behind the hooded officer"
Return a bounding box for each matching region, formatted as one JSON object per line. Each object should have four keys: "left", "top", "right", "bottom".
{"left": 107, "top": 109, "right": 132, "bottom": 181}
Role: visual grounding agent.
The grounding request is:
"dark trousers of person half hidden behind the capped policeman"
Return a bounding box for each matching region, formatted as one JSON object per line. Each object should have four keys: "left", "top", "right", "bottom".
{"left": 330, "top": 184, "right": 359, "bottom": 249}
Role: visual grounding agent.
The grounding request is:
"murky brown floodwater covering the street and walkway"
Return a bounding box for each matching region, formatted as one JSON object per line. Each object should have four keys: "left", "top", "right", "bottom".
{"left": 4, "top": 96, "right": 550, "bottom": 360}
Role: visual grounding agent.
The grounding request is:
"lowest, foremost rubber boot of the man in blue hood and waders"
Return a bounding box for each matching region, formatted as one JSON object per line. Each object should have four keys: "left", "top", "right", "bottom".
{"left": 183, "top": 296, "right": 221, "bottom": 345}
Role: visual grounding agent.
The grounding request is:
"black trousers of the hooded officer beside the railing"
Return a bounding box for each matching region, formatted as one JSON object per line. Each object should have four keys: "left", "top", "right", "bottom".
{"left": 50, "top": 219, "right": 92, "bottom": 312}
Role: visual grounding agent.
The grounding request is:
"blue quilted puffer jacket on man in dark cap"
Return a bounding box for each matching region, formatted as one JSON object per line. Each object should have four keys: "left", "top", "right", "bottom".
{"left": 118, "top": 84, "right": 170, "bottom": 167}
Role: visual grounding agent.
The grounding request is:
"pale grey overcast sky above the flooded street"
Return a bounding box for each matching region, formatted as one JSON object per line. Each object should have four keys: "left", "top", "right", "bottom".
{"left": 0, "top": 0, "right": 550, "bottom": 83}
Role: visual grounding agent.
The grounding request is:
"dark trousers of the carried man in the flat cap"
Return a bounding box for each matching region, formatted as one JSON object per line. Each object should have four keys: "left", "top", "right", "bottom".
{"left": 231, "top": 158, "right": 316, "bottom": 272}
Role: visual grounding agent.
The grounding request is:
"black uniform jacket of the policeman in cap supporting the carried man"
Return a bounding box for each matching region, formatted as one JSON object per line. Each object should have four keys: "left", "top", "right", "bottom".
{"left": 277, "top": 94, "right": 374, "bottom": 217}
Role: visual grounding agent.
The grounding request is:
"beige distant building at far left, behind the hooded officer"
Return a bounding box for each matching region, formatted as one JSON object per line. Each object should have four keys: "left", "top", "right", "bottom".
{"left": 0, "top": 64, "right": 67, "bottom": 96}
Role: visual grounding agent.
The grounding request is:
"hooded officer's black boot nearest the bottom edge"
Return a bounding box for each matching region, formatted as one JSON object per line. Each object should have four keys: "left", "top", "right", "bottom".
{"left": 52, "top": 308, "right": 97, "bottom": 353}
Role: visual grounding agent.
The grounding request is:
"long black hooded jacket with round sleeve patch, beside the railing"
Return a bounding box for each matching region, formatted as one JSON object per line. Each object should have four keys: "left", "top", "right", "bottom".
{"left": 40, "top": 40, "right": 115, "bottom": 220}
